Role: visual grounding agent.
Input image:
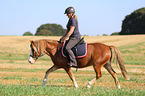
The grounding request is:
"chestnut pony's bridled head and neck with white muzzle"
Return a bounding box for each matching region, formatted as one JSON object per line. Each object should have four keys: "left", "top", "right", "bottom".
{"left": 29, "top": 39, "right": 57, "bottom": 64}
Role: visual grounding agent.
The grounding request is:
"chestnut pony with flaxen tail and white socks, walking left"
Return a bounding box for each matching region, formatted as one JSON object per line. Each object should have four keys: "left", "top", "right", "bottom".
{"left": 29, "top": 39, "right": 129, "bottom": 88}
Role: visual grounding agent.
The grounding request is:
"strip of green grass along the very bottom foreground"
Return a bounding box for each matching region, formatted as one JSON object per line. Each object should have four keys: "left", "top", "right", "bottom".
{"left": 0, "top": 85, "right": 145, "bottom": 96}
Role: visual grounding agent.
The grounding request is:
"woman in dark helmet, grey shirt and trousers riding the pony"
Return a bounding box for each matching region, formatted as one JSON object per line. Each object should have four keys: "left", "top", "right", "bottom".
{"left": 60, "top": 7, "right": 81, "bottom": 67}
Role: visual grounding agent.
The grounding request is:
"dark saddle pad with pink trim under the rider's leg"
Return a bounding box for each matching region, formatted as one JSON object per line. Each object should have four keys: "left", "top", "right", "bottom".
{"left": 61, "top": 42, "right": 87, "bottom": 58}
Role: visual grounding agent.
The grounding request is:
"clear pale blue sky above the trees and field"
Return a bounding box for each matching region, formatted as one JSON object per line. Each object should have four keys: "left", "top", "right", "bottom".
{"left": 0, "top": 0, "right": 145, "bottom": 36}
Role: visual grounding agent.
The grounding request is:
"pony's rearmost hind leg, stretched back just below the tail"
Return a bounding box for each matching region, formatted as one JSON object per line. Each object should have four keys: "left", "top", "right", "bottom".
{"left": 104, "top": 61, "right": 120, "bottom": 89}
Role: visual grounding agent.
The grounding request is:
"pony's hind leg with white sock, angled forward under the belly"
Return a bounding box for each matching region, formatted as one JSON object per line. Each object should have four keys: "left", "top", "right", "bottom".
{"left": 87, "top": 66, "right": 102, "bottom": 88}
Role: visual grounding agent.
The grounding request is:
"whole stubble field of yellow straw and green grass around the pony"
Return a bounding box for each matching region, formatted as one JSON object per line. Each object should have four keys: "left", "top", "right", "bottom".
{"left": 0, "top": 35, "right": 145, "bottom": 96}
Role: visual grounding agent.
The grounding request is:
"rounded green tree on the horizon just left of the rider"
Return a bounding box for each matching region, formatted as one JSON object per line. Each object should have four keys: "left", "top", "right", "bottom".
{"left": 35, "top": 24, "right": 66, "bottom": 36}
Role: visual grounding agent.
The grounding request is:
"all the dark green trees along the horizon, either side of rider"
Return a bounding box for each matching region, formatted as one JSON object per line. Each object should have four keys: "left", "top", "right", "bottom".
{"left": 23, "top": 7, "right": 145, "bottom": 36}
